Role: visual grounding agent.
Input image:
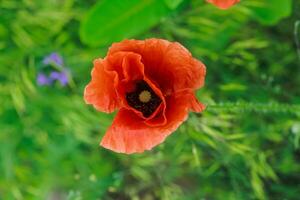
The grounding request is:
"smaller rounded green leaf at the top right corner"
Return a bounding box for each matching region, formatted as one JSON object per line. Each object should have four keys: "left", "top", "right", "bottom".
{"left": 249, "top": 0, "right": 292, "bottom": 25}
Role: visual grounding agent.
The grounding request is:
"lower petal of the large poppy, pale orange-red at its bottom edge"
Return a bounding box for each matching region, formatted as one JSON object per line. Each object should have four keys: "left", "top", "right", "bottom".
{"left": 100, "top": 91, "right": 204, "bottom": 154}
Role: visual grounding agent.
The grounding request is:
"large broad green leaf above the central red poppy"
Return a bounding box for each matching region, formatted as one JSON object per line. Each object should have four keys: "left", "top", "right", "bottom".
{"left": 80, "top": 0, "right": 171, "bottom": 46}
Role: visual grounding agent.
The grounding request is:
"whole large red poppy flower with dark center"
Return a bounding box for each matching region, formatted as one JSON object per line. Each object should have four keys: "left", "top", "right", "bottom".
{"left": 84, "top": 39, "right": 206, "bottom": 154}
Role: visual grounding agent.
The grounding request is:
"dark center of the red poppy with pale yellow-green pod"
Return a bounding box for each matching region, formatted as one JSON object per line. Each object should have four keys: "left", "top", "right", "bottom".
{"left": 126, "top": 81, "right": 161, "bottom": 117}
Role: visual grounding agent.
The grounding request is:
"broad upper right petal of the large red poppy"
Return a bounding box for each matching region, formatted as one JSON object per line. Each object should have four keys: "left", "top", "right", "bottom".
{"left": 109, "top": 39, "right": 206, "bottom": 94}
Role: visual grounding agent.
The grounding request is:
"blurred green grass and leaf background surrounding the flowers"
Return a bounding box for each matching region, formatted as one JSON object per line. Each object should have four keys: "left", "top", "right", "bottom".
{"left": 0, "top": 0, "right": 300, "bottom": 200}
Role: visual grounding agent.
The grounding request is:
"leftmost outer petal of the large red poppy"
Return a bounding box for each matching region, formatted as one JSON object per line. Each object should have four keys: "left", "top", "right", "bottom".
{"left": 84, "top": 59, "right": 119, "bottom": 113}
